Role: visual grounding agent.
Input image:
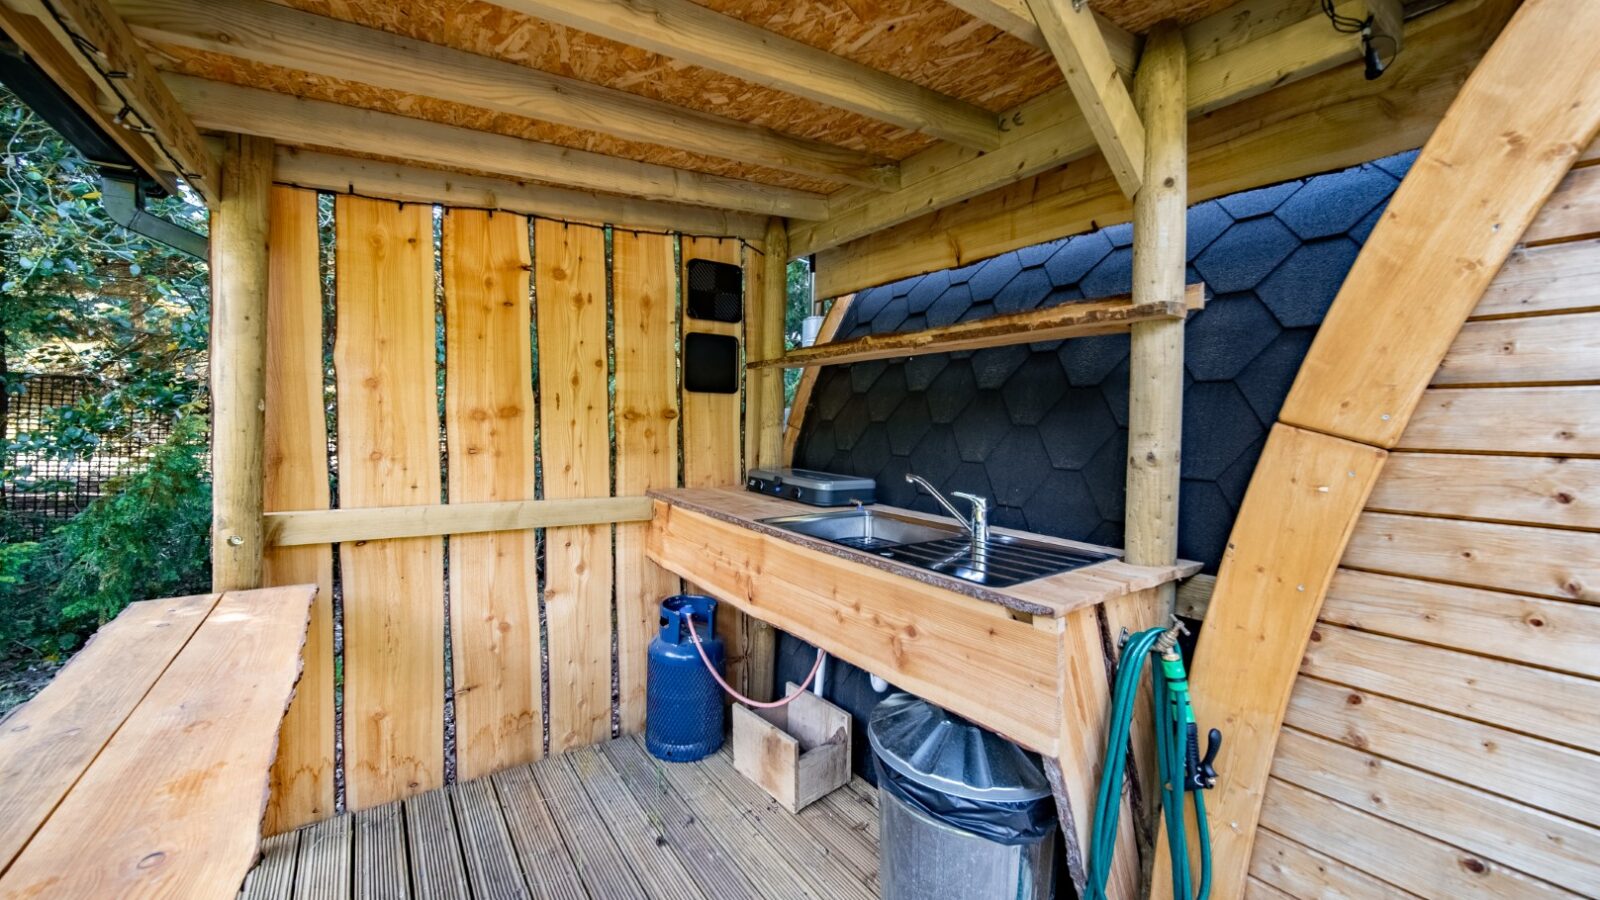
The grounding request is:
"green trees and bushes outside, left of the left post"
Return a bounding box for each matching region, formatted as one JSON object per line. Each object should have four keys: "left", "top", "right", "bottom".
{"left": 0, "top": 88, "right": 210, "bottom": 661}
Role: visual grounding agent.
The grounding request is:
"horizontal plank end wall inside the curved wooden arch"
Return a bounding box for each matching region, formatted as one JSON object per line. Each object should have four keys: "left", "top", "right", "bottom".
{"left": 1251, "top": 147, "right": 1600, "bottom": 897}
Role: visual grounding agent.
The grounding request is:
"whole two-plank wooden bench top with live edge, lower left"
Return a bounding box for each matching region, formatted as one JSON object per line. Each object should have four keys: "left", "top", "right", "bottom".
{"left": 0, "top": 585, "right": 317, "bottom": 898}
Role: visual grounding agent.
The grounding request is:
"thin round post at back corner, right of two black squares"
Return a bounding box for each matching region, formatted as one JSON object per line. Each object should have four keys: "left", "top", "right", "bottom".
{"left": 744, "top": 216, "right": 789, "bottom": 701}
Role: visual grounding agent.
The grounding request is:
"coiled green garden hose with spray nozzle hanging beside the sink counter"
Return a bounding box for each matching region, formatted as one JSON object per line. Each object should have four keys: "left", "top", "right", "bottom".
{"left": 1086, "top": 625, "right": 1222, "bottom": 900}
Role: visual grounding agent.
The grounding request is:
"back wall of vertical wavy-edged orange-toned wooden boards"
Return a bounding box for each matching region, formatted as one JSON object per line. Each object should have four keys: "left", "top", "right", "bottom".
{"left": 266, "top": 194, "right": 742, "bottom": 834}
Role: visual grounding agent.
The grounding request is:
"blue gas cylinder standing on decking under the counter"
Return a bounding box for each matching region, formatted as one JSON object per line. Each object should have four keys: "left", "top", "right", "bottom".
{"left": 645, "top": 594, "right": 723, "bottom": 762}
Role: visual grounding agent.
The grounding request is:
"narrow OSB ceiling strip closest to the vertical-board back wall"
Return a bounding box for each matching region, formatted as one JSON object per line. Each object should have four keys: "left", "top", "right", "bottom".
{"left": 155, "top": 45, "right": 837, "bottom": 194}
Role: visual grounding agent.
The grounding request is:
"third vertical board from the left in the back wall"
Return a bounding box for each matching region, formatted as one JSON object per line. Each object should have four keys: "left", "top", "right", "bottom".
{"left": 442, "top": 210, "right": 544, "bottom": 780}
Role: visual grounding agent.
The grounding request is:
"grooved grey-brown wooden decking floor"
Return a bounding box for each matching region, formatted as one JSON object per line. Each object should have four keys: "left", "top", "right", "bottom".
{"left": 242, "top": 737, "right": 878, "bottom": 900}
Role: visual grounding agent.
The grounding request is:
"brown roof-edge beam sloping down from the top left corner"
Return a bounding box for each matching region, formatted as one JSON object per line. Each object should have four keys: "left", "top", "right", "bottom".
{"left": 5, "top": 0, "right": 219, "bottom": 205}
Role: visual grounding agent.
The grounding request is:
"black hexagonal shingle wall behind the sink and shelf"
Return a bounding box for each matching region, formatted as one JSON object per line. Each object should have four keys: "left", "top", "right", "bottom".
{"left": 779, "top": 152, "right": 1416, "bottom": 762}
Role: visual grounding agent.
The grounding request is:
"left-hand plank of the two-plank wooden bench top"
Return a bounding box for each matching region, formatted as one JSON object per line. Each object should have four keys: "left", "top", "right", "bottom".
{"left": 0, "top": 594, "right": 219, "bottom": 874}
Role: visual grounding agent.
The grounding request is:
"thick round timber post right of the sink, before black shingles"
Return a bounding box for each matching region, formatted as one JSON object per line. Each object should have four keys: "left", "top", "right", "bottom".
{"left": 1106, "top": 22, "right": 1189, "bottom": 860}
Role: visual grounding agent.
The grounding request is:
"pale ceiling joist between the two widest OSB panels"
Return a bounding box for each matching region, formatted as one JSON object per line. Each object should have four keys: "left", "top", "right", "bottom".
{"left": 496, "top": 0, "right": 1003, "bottom": 151}
